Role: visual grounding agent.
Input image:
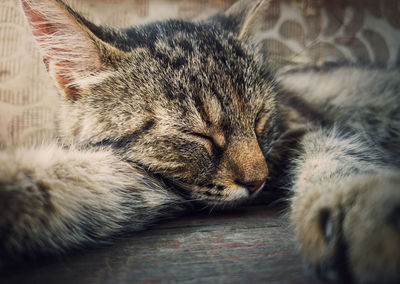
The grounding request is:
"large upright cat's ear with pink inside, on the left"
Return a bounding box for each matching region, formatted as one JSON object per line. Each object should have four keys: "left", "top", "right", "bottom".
{"left": 22, "top": 0, "right": 123, "bottom": 100}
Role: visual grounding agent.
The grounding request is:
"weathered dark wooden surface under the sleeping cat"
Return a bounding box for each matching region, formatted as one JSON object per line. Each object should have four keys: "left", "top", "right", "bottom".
{"left": 0, "top": 206, "right": 318, "bottom": 284}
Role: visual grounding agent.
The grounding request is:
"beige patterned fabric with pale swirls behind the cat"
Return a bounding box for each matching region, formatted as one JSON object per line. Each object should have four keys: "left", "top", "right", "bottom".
{"left": 0, "top": 0, "right": 400, "bottom": 146}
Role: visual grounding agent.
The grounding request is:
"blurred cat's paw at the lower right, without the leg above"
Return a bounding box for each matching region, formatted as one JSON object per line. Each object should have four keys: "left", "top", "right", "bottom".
{"left": 291, "top": 174, "right": 400, "bottom": 283}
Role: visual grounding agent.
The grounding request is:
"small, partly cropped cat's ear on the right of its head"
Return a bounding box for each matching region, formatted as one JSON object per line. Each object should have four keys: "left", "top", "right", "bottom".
{"left": 213, "top": 0, "right": 270, "bottom": 39}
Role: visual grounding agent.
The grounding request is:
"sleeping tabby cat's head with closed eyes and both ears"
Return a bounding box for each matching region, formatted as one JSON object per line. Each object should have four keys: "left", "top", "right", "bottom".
{"left": 22, "top": 0, "right": 278, "bottom": 205}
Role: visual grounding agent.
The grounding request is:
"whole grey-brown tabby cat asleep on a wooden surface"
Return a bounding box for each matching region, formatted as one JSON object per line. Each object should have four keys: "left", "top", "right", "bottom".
{"left": 0, "top": 0, "right": 400, "bottom": 282}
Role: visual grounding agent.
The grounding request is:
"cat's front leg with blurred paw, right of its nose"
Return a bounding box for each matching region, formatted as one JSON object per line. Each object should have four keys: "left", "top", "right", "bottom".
{"left": 290, "top": 127, "right": 400, "bottom": 283}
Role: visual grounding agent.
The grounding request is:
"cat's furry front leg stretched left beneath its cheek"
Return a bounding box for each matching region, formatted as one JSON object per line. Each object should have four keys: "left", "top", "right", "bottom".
{"left": 0, "top": 144, "right": 185, "bottom": 262}
